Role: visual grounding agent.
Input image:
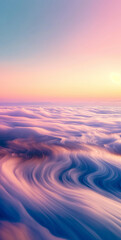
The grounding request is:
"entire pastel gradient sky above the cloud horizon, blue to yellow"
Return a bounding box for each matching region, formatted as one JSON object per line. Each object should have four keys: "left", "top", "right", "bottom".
{"left": 0, "top": 0, "right": 121, "bottom": 102}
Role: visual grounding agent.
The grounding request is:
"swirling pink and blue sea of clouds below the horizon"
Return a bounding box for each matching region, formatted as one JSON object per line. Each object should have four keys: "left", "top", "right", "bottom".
{"left": 0, "top": 105, "right": 121, "bottom": 240}
